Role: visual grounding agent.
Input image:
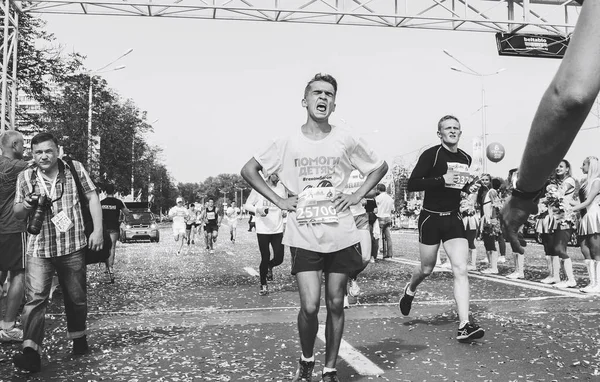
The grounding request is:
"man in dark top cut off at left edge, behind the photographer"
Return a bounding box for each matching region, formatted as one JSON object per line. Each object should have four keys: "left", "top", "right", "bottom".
{"left": 0, "top": 130, "right": 29, "bottom": 342}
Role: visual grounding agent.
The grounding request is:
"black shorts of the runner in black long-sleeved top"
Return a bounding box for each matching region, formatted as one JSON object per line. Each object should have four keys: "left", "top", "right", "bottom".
{"left": 419, "top": 210, "right": 467, "bottom": 245}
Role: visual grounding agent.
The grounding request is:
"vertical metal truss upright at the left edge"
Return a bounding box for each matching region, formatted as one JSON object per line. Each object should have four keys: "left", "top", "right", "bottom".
{"left": 0, "top": 0, "right": 19, "bottom": 134}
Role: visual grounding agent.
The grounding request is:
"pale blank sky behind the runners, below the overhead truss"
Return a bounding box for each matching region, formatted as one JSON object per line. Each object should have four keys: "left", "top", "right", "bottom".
{"left": 43, "top": 15, "right": 600, "bottom": 182}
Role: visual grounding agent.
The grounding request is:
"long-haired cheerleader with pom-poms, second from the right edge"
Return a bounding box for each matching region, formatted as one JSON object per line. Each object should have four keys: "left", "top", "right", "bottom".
{"left": 545, "top": 159, "right": 577, "bottom": 288}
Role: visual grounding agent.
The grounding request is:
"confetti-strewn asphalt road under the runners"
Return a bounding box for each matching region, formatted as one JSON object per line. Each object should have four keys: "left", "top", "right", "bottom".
{"left": 0, "top": 222, "right": 600, "bottom": 382}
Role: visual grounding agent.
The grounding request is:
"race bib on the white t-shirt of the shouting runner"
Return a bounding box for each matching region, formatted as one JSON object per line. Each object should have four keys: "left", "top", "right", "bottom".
{"left": 296, "top": 187, "right": 338, "bottom": 224}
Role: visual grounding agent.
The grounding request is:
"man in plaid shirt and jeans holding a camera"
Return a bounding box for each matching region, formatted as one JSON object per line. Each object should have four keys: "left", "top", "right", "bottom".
{"left": 13, "top": 133, "right": 104, "bottom": 372}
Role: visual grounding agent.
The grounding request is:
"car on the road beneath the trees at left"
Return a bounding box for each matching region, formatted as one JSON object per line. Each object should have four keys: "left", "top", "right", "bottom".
{"left": 120, "top": 202, "right": 160, "bottom": 243}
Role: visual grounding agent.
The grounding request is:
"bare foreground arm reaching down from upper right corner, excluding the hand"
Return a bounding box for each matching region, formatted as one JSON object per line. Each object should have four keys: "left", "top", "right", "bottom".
{"left": 518, "top": 1, "right": 600, "bottom": 191}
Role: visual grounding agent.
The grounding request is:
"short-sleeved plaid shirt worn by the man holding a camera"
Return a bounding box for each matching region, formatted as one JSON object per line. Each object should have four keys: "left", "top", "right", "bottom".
{"left": 15, "top": 159, "right": 96, "bottom": 258}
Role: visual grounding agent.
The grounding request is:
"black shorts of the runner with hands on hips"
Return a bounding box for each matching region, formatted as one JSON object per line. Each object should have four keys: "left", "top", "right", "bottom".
{"left": 290, "top": 243, "right": 364, "bottom": 275}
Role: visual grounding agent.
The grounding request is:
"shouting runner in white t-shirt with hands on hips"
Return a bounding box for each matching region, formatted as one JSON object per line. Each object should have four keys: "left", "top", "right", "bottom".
{"left": 242, "top": 74, "right": 388, "bottom": 381}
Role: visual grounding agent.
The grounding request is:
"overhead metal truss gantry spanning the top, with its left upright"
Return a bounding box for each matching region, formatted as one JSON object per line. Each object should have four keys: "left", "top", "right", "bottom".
{"left": 2, "top": 0, "right": 580, "bottom": 131}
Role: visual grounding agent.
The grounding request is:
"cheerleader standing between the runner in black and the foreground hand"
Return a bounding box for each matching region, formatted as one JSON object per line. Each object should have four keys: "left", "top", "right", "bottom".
{"left": 477, "top": 174, "right": 500, "bottom": 274}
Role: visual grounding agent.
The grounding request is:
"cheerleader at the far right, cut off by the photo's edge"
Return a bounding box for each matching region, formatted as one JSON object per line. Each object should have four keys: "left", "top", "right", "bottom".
{"left": 573, "top": 157, "right": 600, "bottom": 293}
